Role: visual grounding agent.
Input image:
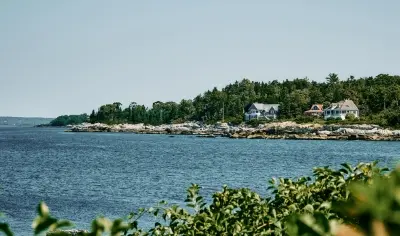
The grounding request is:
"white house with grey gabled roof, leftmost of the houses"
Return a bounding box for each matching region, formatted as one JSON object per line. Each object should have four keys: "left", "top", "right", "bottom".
{"left": 244, "top": 103, "right": 279, "bottom": 121}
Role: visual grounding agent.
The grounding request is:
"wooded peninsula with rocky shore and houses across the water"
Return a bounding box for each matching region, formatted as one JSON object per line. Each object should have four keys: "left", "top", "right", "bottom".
{"left": 51, "top": 73, "right": 400, "bottom": 140}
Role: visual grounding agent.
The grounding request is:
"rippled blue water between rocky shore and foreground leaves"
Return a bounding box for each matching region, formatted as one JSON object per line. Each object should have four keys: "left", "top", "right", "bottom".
{"left": 0, "top": 128, "right": 400, "bottom": 235}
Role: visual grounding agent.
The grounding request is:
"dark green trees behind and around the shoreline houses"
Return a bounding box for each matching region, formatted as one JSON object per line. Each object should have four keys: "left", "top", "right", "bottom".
{"left": 83, "top": 73, "right": 400, "bottom": 125}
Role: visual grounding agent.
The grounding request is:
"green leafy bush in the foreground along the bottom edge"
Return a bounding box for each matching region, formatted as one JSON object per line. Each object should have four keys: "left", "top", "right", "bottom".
{"left": 0, "top": 162, "right": 400, "bottom": 236}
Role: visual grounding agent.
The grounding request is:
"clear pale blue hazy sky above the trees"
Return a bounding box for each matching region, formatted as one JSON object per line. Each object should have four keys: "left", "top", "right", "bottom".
{"left": 0, "top": 0, "right": 400, "bottom": 117}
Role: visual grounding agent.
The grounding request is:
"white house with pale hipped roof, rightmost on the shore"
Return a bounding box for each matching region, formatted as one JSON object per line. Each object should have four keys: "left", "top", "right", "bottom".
{"left": 324, "top": 99, "right": 360, "bottom": 120}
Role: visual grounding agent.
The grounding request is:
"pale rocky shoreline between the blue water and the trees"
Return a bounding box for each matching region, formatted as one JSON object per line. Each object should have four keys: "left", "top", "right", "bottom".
{"left": 66, "top": 122, "right": 400, "bottom": 141}
